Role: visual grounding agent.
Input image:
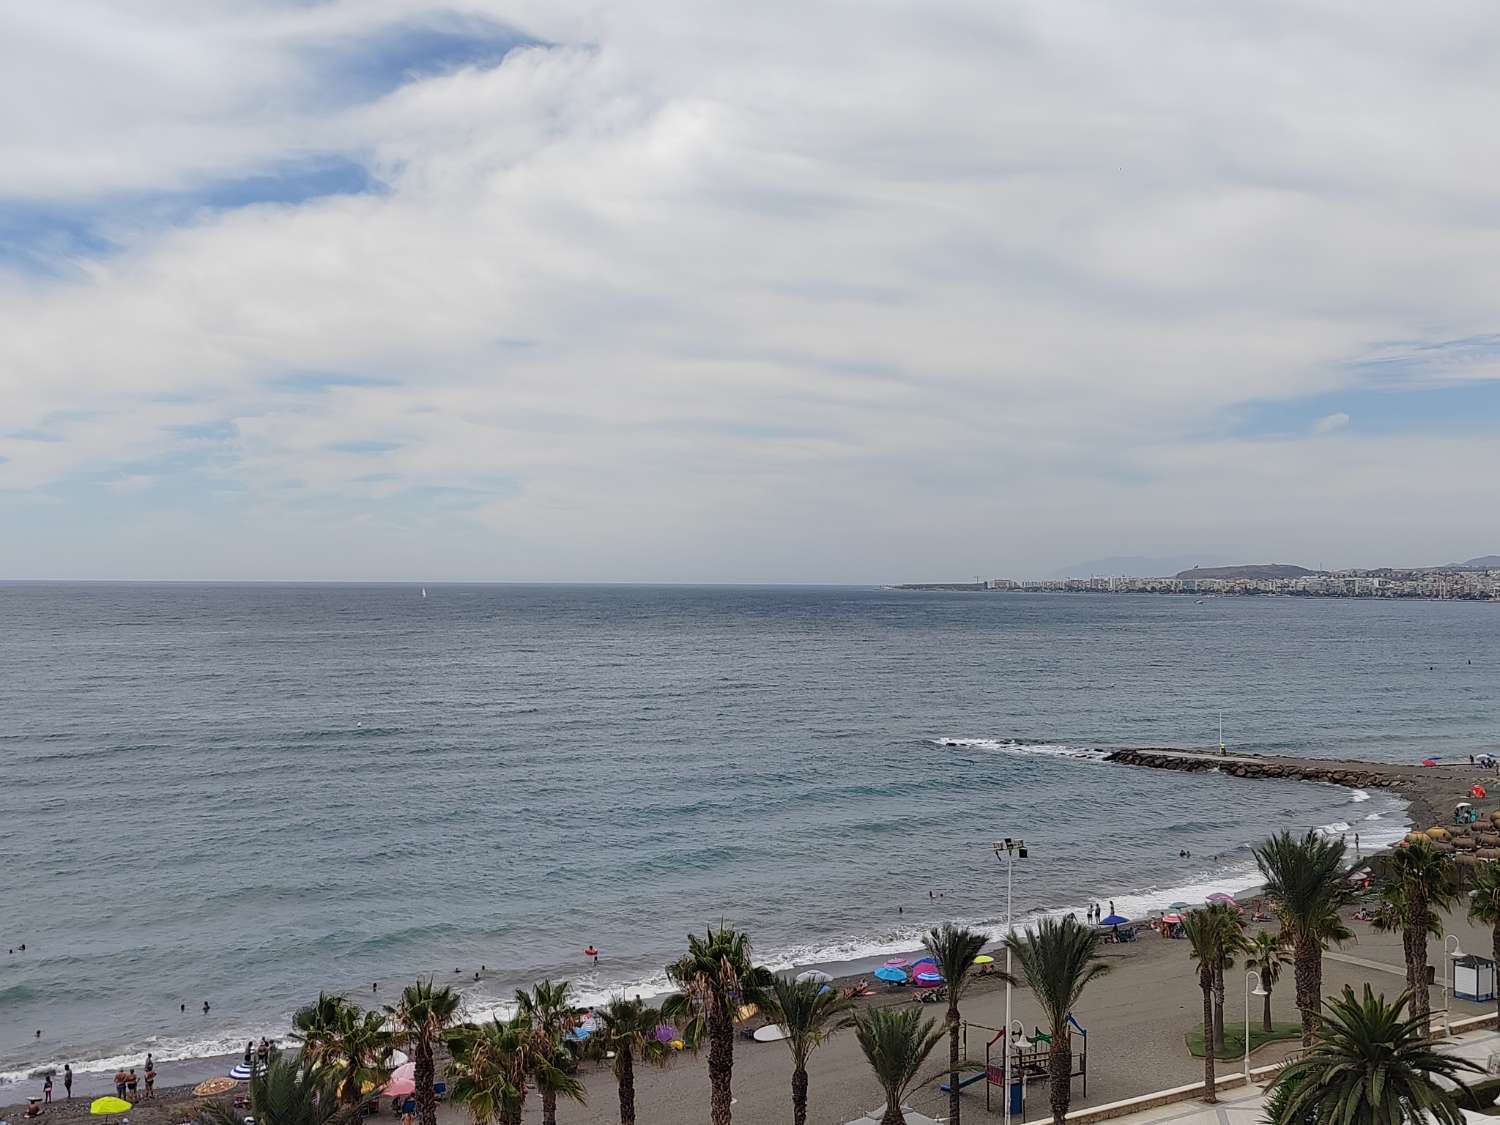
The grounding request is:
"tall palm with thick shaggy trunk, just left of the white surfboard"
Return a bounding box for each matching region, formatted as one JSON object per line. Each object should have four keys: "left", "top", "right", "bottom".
{"left": 666, "top": 926, "right": 771, "bottom": 1125}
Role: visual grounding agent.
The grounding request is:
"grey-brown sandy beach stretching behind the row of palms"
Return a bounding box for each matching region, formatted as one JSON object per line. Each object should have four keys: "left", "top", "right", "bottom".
{"left": 14, "top": 756, "right": 1494, "bottom": 1125}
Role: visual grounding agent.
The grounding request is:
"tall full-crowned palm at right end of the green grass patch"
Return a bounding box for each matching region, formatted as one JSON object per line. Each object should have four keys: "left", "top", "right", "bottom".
{"left": 1256, "top": 830, "right": 1353, "bottom": 1047}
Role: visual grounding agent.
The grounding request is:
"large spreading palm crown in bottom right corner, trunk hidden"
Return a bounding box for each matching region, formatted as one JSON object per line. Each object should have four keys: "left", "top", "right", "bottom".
{"left": 1266, "top": 984, "right": 1482, "bottom": 1125}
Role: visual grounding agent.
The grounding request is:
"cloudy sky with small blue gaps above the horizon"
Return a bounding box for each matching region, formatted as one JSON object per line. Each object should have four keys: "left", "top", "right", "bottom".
{"left": 0, "top": 0, "right": 1500, "bottom": 582}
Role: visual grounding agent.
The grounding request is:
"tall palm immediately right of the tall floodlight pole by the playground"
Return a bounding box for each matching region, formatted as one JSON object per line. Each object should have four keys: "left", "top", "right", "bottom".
{"left": 1008, "top": 915, "right": 1110, "bottom": 1125}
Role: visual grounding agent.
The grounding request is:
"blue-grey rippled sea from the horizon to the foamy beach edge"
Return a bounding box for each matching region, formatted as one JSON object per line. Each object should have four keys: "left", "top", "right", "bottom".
{"left": 0, "top": 584, "right": 1500, "bottom": 1082}
